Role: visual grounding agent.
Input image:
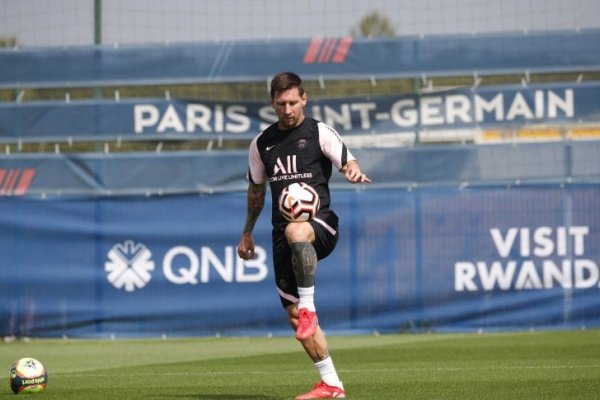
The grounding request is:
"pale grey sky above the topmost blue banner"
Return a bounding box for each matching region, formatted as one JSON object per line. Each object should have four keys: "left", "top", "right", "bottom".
{"left": 0, "top": 0, "right": 600, "bottom": 47}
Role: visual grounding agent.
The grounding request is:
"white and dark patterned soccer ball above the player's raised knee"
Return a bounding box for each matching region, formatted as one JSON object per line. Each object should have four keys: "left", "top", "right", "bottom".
{"left": 279, "top": 182, "right": 320, "bottom": 222}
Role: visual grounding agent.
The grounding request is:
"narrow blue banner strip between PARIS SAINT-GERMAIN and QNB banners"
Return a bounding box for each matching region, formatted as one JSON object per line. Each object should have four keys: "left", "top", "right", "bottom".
{"left": 0, "top": 141, "right": 600, "bottom": 197}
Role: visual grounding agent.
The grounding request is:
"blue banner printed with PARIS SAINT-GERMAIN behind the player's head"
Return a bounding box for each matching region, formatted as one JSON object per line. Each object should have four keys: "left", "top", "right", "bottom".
{"left": 0, "top": 83, "right": 600, "bottom": 141}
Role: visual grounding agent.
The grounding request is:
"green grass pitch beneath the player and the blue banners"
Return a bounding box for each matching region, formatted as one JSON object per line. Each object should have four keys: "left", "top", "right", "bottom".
{"left": 0, "top": 330, "right": 600, "bottom": 400}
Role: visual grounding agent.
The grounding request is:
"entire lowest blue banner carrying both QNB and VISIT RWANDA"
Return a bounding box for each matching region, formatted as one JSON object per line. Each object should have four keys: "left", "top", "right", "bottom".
{"left": 0, "top": 184, "right": 600, "bottom": 337}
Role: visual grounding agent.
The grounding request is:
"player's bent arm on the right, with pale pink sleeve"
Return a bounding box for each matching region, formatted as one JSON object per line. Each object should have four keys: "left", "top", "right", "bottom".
{"left": 318, "top": 122, "right": 371, "bottom": 183}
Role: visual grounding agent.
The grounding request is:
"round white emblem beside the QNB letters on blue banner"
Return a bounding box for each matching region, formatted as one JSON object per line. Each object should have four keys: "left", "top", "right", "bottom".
{"left": 104, "top": 240, "right": 154, "bottom": 292}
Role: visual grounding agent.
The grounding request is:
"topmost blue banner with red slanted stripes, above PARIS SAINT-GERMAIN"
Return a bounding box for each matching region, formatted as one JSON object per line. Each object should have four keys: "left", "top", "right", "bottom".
{"left": 0, "top": 30, "right": 600, "bottom": 88}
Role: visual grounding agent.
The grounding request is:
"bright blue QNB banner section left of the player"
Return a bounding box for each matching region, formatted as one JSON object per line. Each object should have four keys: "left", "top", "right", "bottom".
{"left": 0, "top": 194, "right": 281, "bottom": 337}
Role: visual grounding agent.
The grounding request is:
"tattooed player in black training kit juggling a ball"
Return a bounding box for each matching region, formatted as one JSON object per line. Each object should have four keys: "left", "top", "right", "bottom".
{"left": 238, "top": 72, "right": 371, "bottom": 400}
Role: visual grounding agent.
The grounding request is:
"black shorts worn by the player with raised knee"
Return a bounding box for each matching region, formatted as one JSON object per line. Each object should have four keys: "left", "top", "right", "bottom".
{"left": 273, "top": 210, "right": 339, "bottom": 308}
